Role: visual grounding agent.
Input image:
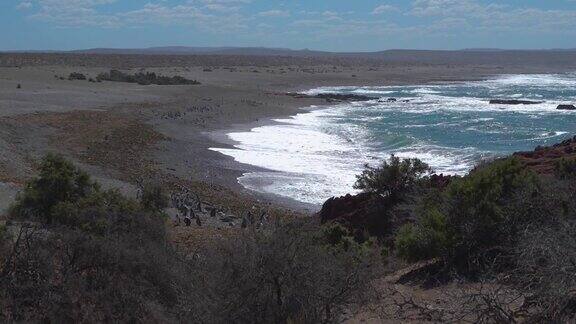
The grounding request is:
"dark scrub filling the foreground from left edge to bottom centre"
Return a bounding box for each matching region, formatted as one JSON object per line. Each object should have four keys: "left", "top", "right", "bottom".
{"left": 0, "top": 155, "right": 380, "bottom": 323}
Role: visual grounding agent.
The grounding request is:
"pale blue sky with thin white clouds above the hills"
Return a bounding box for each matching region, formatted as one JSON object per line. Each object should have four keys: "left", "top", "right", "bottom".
{"left": 0, "top": 0, "right": 576, "bottom": 51}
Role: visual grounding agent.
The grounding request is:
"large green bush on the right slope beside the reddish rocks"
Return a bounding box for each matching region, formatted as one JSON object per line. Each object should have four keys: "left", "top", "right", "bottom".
{"left": 396, "top": 158, "right": 539, "bottom": 269}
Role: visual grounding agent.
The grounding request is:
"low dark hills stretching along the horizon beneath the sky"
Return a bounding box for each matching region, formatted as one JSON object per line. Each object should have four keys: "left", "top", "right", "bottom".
{"left": 0, "top": 46, "right": 576, "bottom": 71}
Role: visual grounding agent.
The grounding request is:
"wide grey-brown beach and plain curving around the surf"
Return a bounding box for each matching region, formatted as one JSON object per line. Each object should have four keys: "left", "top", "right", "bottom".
{"left": 0, "top": 54, "right": 576, "bottom": 214}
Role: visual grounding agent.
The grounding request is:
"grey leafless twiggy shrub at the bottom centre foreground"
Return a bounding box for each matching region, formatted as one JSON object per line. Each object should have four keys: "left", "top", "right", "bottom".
{"left": 184, "top": 222, "right": 378, "bottom": 323}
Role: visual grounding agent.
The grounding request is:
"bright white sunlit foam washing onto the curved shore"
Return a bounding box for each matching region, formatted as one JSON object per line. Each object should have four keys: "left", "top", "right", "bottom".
{"left": 211, "top": 110, "right": 366, "bottom": 203}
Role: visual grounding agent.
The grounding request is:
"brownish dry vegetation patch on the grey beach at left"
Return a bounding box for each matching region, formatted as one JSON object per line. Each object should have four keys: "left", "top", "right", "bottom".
{"left": 3, "top": 111, "right": 166, "bottom": 181}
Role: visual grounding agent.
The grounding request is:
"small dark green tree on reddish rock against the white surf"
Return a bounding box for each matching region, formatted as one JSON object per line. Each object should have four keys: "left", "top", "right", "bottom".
{"left": 354, "top": 155, "right": 431, "bottom": 201}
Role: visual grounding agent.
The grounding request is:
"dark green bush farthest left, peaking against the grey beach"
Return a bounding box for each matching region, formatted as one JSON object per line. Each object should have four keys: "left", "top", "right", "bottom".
{"left": 10, "top": 154, "right": 99, "bottom": 223}
